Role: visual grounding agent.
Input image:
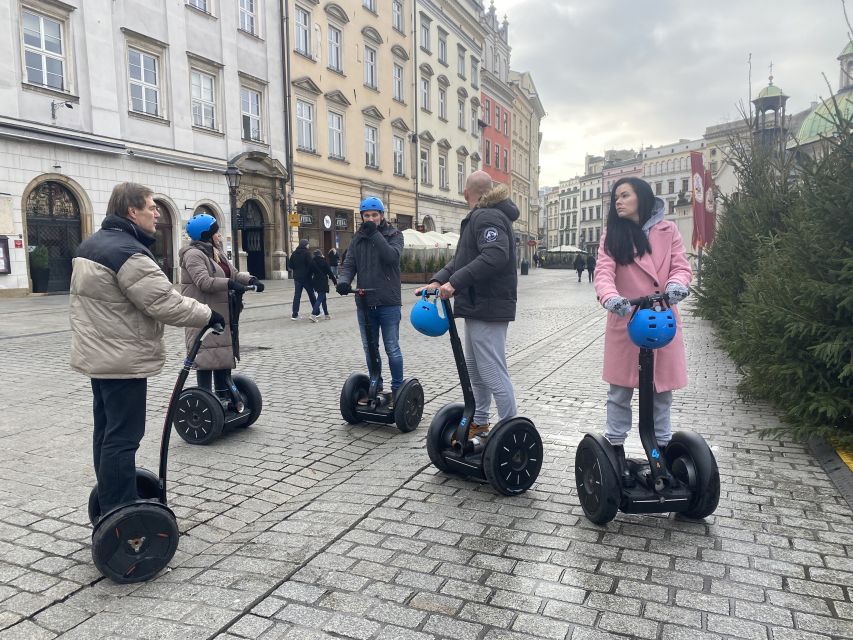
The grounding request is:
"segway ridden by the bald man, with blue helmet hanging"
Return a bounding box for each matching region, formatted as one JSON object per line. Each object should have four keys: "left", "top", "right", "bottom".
{"left": 412, "top": 289, "right": 543, "bottom": 496}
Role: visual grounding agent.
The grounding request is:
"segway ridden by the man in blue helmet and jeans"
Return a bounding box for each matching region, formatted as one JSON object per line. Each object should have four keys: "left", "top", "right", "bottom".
{"left": 340, "top": 289, "right": 424, "bottom": 433}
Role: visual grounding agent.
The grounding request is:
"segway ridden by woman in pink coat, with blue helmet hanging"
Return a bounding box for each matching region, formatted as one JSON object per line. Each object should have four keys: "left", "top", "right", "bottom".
{"left": 575, "top": 293, "right": 720, "bottom": 524}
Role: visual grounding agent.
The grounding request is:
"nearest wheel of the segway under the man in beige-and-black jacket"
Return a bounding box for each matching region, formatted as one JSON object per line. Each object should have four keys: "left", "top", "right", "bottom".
{"left": 92, "top": 502, "right": 179, "bottom": 584}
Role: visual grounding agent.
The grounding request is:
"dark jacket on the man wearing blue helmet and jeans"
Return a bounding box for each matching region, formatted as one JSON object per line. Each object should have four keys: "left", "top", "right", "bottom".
{"left": 338, "top": 220, "right": 403, "bottom": 307}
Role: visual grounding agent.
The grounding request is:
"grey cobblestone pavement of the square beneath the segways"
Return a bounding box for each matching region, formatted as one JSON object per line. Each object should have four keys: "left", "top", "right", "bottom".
{"left": 0, "top": 270, "right": 853, "bottom": 640}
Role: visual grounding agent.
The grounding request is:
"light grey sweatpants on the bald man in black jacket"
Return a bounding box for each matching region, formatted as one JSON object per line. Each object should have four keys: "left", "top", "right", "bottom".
{"left": 465, "top": 318, "right": 516, "bottom": 425}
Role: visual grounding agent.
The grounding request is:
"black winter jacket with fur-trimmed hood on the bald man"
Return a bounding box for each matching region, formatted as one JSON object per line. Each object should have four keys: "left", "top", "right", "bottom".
{"left": 433, "top": 185, "right": 519, "bottom": 322}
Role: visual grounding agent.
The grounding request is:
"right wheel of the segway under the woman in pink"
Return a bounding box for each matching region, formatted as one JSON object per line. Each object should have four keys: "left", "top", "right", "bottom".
{"left": 664, "top": 431, "right": 720, "bottom": 520}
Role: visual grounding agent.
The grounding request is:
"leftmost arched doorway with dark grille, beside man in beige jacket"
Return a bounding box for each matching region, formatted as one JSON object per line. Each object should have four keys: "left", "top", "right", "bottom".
{"left": 26, "top": 181, "right": 81, "bottom": 293}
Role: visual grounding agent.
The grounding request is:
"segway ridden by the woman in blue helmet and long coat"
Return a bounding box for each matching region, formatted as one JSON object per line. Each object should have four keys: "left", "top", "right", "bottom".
{"left": 174, "top": 285, "right": 263, "bottom": 444}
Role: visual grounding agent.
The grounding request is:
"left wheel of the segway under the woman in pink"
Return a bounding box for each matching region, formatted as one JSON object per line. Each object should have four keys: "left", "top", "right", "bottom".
{"left": 575, "top": 436, "right": 622, "bottom": 524}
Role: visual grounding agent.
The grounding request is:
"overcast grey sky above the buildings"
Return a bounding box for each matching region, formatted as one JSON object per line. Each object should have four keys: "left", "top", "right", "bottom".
{"left": 492, "top": 0, "right": 853, "bottom": 186}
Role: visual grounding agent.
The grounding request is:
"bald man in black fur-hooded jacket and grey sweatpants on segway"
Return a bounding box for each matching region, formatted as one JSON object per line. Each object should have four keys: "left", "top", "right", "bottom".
{"left": 416, "top": 171, "right": 519, "bottom": 438}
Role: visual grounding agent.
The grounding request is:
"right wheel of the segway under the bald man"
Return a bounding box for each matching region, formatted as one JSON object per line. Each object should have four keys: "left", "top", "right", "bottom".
{"left": 483, "top": 417, "right": 543, "bottom": 496}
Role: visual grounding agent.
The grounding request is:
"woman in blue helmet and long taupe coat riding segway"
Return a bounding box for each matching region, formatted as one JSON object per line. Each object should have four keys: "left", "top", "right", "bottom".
{"left": 179, "top": 214, "right": 263, "bottom": 395}
